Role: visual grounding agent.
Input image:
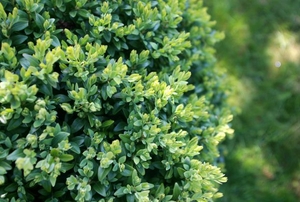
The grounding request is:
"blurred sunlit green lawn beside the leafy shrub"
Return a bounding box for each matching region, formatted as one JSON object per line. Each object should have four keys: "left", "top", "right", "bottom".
{"left": 204, "top": 0, "right": 300, "bottom": 202}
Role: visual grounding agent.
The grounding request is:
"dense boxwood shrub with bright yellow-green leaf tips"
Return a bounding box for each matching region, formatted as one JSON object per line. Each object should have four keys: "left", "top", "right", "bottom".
{"left": 0, "top": 0, "right": 232, "bottom": 202}
